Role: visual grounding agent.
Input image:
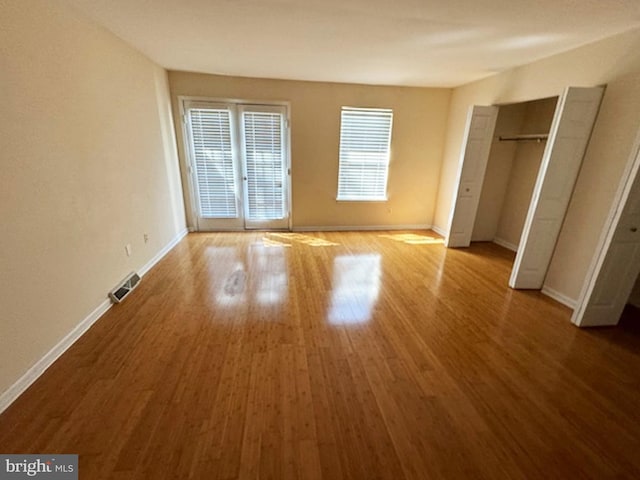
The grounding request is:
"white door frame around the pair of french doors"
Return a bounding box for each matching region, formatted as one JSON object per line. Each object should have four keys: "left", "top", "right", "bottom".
{"left": 177, "top": 95, "right": 293, "bottom": 231}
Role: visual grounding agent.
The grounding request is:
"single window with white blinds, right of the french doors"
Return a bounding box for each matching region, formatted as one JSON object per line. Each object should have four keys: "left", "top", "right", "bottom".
{"left": 337, "top": 107, "right": 393, "bottom": 201}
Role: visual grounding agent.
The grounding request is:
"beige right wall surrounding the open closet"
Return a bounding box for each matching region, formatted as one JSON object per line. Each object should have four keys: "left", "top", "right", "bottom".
{"left": 434, "top": 26, "right": 640, "bottom": 299}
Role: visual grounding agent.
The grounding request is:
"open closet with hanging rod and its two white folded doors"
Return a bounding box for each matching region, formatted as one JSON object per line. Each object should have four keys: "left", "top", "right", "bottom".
{"left": 445, "top": 87, "right": 604, "bottom": 290}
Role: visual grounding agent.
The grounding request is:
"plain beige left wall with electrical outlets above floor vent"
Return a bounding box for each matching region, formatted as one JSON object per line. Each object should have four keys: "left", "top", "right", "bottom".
{"left": 0, "top": 0, "right": 185, "bottom": 395}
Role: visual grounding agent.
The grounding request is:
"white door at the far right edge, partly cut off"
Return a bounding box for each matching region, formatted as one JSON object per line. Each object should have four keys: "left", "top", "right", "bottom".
{"left": 571, "top": 137, "right": 640, "bottom": 327}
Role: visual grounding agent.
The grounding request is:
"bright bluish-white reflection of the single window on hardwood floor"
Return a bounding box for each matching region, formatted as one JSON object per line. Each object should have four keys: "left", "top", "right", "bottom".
{"left": 328, "top": 254, "right": 381, "bottom": 324}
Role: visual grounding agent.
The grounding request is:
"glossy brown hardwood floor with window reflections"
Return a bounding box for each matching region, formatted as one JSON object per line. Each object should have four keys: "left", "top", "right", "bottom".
{"left": 0, "top": 232, "right": 640, "bottom": 480}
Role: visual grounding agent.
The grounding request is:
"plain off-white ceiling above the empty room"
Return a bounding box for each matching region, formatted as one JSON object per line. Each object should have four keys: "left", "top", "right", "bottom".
{"left": 63, "top": 0, "right": 640, "bottom": 87}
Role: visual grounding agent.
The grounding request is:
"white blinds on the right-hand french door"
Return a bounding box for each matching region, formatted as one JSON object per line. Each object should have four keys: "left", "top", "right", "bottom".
{"left": 242, "top": 107, "right": 286, "bottom": 220}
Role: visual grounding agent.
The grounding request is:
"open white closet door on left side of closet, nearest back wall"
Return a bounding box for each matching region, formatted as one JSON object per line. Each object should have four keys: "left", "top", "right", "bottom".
{"left": 445, "top": 106, "right": 498, "bottom": 247}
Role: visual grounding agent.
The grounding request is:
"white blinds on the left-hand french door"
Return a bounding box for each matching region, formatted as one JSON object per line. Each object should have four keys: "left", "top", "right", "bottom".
{"left": 189, "top": 108, "right": 238, "bottom": 218}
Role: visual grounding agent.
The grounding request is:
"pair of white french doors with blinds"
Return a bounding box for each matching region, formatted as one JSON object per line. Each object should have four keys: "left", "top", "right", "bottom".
{"left": 182, "top": 100, "right": 289, "bottom": 231}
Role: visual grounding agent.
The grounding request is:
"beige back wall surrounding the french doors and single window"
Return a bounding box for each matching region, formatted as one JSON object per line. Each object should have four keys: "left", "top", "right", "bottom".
{"left": 169, "top": 72, "right": 451, "bottom": 228}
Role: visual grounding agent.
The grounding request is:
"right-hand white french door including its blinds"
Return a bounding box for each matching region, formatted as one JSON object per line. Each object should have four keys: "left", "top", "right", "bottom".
{"left": 238, "top": 105, "right": 289, "bottom": 229}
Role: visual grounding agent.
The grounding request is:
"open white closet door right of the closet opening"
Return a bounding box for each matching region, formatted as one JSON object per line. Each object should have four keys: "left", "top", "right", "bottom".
{"left": 509, "top": 87, "right": 604, "bottom": 289}
